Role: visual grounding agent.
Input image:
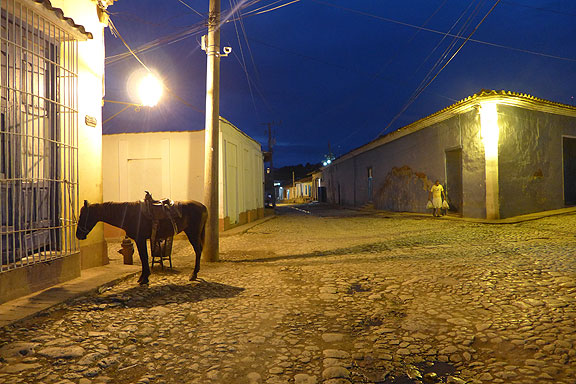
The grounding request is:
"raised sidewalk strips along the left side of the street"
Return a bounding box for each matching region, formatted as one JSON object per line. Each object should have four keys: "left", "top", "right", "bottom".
{"left": 0, "top": 216, "right": 276, "bottom": 327}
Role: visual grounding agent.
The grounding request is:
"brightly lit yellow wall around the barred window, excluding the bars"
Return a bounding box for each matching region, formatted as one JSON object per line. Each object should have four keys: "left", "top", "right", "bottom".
{"left": 0, "top": 0, "right": 108, "bottom": 303}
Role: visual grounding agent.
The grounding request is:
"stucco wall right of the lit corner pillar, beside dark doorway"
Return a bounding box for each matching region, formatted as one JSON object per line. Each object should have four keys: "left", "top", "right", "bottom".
{"left": 498, "top": 105, "right": 576, "bottom": 218}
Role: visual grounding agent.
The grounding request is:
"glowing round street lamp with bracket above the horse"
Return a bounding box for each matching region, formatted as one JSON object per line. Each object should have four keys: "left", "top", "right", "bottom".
{"left": 102, "top": 72, "right": 164, "bottom": 125}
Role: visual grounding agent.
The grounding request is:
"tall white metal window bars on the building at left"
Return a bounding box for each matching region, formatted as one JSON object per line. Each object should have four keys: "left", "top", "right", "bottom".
{"left": 0, "top": 0, "right": 78, "bottom": 273}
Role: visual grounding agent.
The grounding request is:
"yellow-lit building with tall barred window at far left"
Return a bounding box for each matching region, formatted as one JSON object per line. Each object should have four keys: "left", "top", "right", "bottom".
{"left": 0, "top": 0, "right": 113, "bottom": 302}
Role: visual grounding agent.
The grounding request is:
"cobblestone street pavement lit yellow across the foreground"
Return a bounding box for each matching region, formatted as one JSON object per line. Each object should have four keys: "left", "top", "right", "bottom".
{"left": 0, "top": 207, "right": 576, "bottom": 384}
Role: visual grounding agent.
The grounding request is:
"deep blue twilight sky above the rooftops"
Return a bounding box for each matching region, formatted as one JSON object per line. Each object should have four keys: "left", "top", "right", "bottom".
{"left": 103, "top": 0, "right": 576, "bottom": 166}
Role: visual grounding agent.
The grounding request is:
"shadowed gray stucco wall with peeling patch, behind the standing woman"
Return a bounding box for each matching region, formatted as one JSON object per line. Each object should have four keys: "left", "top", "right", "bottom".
{"left": 324, "top": 110, "right": 485, "bottom": 217}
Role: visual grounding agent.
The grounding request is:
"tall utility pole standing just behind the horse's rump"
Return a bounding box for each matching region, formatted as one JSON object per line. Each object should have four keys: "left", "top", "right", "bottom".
{"left": 202, "top": 0, "right": 220, "bottom": 261}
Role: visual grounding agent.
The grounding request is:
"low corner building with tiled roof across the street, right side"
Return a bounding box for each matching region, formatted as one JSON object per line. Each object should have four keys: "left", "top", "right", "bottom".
{"left": 323, "top": 91, "right": 576, "bottom": 219}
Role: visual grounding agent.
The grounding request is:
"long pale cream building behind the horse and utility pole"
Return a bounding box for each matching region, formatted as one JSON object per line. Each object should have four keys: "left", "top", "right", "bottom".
{"left": 103, "top": 118, "right": 264, "bottom": 237}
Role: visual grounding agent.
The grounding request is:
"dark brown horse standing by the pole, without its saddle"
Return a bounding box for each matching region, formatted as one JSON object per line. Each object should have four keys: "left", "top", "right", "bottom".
{"left": 76, "top": 200, "right": 208, "bottom": 284}
